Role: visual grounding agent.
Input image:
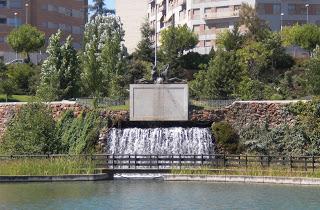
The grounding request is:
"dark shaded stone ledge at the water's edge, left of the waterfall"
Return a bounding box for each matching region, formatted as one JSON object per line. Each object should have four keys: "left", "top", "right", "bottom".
{"left": 0, "top": 173, "right": 113, "bottom": 183}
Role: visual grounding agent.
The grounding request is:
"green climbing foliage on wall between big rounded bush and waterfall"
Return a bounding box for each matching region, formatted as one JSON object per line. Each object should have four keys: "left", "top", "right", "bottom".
{"left": 57, "top": 111, "right": 104, "bottom": 154}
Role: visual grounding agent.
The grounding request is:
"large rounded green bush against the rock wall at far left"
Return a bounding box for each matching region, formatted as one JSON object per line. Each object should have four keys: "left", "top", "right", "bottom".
{"left": 0, "top": 103, "right": 60, "bottom": 155}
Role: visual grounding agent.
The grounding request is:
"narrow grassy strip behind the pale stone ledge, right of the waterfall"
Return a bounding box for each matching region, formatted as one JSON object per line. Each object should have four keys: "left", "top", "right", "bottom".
{"left": 171, "top": 167, "right": 320, "bottom": 178}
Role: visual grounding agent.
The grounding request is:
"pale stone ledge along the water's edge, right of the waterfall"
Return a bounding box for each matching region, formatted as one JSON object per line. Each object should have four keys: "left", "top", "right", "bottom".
{"left": 163, "top": 175, "right": 320, "bottom": 185}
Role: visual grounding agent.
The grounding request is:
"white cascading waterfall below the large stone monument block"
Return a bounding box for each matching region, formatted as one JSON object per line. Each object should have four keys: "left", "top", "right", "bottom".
{"left": 107, "top": 127, "right": 214, "bottom": 155}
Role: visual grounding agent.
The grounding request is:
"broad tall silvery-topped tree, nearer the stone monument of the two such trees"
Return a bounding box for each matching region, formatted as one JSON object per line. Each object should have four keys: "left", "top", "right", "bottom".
{"left": 82, "top": 15, "right": 126, "bottom": 97}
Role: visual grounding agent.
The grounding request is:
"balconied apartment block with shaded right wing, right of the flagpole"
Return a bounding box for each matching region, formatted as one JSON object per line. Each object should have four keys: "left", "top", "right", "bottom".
{"left": 148, "top": 0, "right": 320, "bottom": 54}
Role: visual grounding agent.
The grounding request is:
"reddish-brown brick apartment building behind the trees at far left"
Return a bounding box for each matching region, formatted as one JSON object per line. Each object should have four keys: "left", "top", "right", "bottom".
{"left": 0, "top": 0, "right": 88, "bottom": 62}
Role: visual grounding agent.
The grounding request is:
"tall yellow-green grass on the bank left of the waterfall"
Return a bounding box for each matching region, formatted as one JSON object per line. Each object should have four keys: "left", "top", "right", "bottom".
{"left": 0, "top": 157, "right": 96, "bottom": 176}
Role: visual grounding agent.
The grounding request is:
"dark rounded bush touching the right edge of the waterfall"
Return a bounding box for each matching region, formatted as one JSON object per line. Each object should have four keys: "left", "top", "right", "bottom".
{"left": 212, "top": 122, "right": 240, "bottom": 153}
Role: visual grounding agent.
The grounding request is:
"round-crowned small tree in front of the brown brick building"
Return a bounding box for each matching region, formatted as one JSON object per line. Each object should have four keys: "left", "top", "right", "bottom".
{"left": 8, "top": 25, "right": 45, "bottom": 62}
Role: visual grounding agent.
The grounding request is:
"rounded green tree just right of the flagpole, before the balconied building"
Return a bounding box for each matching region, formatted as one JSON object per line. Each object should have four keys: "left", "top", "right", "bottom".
{"left": 160, "top": 25, "right": 199, "bottom": 77}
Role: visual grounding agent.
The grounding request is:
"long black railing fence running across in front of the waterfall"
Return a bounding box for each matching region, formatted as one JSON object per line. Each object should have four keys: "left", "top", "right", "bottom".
{"left": 0, "top": 154, "right": 320, "bottom": 171}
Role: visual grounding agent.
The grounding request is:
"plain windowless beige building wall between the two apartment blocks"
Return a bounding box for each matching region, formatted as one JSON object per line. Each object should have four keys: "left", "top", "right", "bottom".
{"left": 116, "top": 0, "right": 149, "bottom": 53}
